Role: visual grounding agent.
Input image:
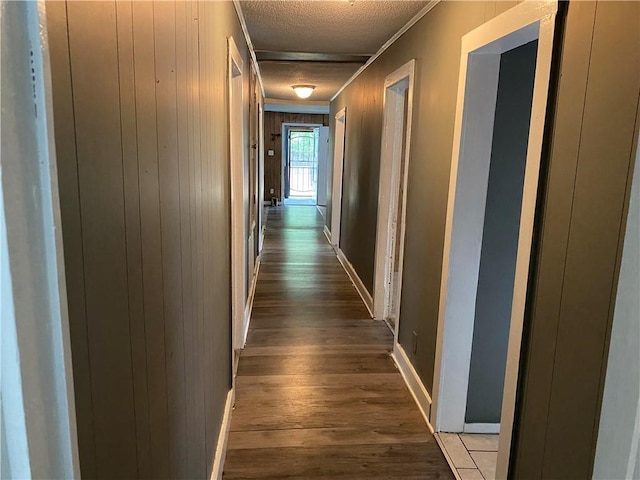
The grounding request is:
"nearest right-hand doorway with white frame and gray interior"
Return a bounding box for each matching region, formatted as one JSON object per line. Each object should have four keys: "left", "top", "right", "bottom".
{"left": 430, "top": 2, "right": 557, "bottom": 478}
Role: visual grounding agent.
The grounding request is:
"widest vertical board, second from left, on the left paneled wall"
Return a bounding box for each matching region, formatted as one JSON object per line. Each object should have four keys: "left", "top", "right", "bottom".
{"left": 67, "top": 2, "right": 137, "bottom": 478}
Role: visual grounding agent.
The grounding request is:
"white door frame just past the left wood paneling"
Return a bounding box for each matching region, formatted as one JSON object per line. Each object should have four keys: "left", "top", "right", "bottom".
{"left": 227, "top": 37, "right": 247, "bottom": 360}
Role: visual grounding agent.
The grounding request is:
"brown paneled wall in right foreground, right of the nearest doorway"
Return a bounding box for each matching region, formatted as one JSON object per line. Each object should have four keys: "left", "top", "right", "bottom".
{"left": 512, "top": 2, "right": 640, "bottom": 479}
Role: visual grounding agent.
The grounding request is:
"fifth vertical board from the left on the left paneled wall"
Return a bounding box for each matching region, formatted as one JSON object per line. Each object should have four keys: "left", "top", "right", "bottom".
{"left": 153, "top": 2, "right": 187, "bottom": 478}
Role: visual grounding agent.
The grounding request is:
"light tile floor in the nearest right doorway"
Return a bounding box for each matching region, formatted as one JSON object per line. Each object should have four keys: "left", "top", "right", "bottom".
{"left": 438, "top": 433, "right": 498, "bottom": 480}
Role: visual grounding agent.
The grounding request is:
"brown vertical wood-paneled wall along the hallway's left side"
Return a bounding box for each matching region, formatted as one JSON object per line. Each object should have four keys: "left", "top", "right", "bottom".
{"left": 47, "top": 1, "right": 249, "bottom": 478}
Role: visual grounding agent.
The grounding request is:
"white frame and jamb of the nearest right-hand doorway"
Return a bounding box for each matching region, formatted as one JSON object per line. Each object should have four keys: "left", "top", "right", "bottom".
{"left": 431, "top": 1, "right": 557, "bottom": 478}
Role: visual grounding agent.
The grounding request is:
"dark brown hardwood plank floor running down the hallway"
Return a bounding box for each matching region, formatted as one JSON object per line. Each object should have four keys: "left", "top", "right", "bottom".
{"left": 223, "top": 206, "right": 453, "bottom": 480}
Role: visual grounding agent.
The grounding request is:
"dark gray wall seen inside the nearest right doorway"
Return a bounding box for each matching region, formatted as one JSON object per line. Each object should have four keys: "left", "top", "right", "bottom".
{"left": 465, "top": 41, "right": 538, "bottom": 423}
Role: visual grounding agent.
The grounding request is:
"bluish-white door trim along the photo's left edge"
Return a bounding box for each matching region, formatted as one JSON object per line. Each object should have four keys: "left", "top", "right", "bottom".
{"left": 0, "top": 1, "right": 80, "bottom": 479}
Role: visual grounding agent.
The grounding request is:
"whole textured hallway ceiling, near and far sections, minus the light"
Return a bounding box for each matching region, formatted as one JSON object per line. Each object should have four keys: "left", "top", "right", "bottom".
{"left": 240, "top": 0, "right": 427, "bottom": 100}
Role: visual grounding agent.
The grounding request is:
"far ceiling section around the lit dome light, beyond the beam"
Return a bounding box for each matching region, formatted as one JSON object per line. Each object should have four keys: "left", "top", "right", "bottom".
{"left": 260, "top": 62, "right": 361, "bottom": 101}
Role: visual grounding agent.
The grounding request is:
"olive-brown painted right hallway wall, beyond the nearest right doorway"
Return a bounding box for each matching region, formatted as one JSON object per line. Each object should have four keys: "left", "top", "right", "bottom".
{"left": 327, "top": 1, "right": 517, "bottom": 392}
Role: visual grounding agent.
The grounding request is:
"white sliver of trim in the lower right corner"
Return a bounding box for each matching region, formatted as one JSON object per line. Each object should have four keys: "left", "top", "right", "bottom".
{"left": 593, "top": 141, "right": 640, "bottom": 480}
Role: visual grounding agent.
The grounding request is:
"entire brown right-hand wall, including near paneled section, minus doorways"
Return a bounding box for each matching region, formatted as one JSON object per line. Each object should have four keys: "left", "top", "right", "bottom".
{"left": 327, "top": 1, "right": 640, "bottom": 479}
